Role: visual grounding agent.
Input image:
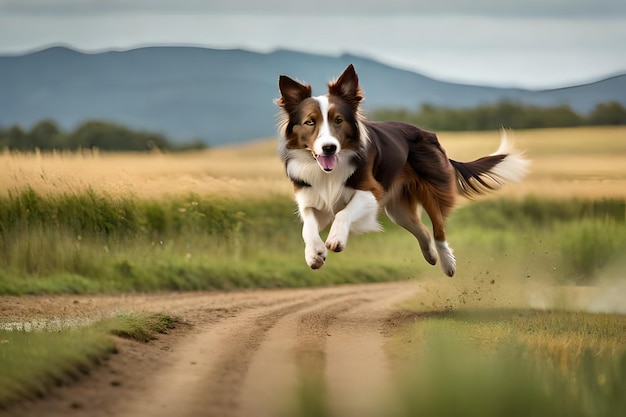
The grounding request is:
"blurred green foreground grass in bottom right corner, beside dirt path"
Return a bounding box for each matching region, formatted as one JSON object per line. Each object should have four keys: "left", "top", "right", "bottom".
{"left": 390, "top": 309, "right": 626, "bottom": 416}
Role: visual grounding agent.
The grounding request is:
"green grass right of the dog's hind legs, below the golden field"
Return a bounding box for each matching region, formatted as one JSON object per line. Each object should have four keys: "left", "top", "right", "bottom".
{"left": 449, "top": 197, "right": 626, "bottom": 285}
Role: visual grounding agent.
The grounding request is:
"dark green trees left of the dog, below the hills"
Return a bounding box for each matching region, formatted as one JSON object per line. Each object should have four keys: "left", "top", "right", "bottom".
{"left": 0, "top": 119, "right": 205, "bottom": 151}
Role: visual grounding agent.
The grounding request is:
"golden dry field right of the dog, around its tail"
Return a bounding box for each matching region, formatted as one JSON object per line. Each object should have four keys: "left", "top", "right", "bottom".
{"left": 439, "top": 127, "right": 626, "bottom": 198}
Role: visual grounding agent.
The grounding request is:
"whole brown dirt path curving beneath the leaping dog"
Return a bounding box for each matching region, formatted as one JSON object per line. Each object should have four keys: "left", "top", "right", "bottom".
{"left": 3, "top": 282, "right": 419, "bottom": 417}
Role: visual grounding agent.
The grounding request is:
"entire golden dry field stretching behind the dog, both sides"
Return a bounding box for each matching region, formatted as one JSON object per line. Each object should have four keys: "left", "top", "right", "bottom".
{"left": 0, "top": 127, "right": 626, "bottom": 198}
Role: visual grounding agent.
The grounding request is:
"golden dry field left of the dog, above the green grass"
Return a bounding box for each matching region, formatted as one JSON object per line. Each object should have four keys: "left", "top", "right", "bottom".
{"left": 0, "top": 141, "right": 291, "bottom": 198}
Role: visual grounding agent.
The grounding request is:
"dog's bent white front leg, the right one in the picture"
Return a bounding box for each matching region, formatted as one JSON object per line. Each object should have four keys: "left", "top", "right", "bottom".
{"left": 326, "top": 190, "right": 380, "bottom": 252}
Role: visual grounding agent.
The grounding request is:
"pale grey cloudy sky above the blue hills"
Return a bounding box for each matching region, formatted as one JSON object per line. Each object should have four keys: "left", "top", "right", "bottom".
{"left": 0, "top": 0, "right": 626, "bottom": 89}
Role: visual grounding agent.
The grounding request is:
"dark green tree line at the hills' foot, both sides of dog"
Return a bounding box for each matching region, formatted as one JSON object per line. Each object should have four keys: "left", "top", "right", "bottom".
{"left": 0, "top": 101, "right": 626, "bottom": 151}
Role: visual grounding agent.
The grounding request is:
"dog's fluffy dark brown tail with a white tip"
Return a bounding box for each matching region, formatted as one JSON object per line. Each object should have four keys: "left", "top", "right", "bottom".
{"left": 450, "top": 130, "right": 530, "bottom": 198}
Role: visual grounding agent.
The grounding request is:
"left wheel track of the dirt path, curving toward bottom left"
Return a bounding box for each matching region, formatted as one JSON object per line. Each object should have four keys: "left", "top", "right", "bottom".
{"left": 115, "top": 297, "right": 326, "bottom": 417}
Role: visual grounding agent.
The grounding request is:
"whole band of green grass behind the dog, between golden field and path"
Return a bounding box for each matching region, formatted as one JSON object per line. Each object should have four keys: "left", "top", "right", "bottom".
{"left": 0, "top": 188, "right": 626, "bottom": 295}
